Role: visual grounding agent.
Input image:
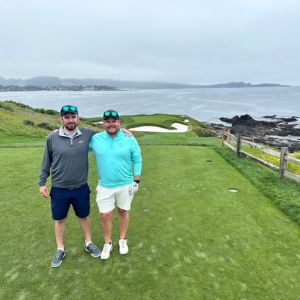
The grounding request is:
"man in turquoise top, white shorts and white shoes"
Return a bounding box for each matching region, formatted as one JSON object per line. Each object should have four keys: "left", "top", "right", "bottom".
{"left": 90, "top": 110, "right": 142, "bottom": 259}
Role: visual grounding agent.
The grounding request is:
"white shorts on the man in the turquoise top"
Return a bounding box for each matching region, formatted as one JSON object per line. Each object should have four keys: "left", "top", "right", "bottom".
{"left": 96, "top": 184, "right": 133, "bottom": 213}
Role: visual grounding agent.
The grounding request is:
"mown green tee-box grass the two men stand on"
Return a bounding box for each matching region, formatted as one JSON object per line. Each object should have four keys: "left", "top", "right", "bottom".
{"left": 0, "top": 146, "right": 300, "bottom": 299}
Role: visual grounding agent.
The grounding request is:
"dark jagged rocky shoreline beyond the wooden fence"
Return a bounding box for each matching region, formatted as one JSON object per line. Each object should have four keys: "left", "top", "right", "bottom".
{"left": 210, "top": 114, "right": 300, "bottom": 152}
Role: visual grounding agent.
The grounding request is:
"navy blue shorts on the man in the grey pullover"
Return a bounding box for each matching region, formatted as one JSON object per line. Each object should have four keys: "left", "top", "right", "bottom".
{"left": 50, "top": 184, "right": 91, "bottom": 221}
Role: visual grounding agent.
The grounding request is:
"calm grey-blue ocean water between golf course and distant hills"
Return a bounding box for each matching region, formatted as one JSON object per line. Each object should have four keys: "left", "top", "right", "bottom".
{"left": 0, "top": 87, "right": 300, "bottom": 127}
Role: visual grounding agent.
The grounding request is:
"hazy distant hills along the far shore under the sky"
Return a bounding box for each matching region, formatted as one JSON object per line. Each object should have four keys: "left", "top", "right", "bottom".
{"left": 0, "top": 76, "right": 287, "bottom": 91}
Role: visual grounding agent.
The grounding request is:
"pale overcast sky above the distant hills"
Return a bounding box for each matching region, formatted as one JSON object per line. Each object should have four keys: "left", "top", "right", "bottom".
{"left": 0, "top": 0, "right": 300, "bottom": 85}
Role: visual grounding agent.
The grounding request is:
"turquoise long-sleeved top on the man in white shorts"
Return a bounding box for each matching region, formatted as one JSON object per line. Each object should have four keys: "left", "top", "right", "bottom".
{"left": 89, "top": 130, "right": 142, "bottom": 188}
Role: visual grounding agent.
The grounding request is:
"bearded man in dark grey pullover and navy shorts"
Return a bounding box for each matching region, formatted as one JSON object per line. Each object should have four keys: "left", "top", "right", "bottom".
{"left": 39, "top": 105, "right": 100, "bottom": 268}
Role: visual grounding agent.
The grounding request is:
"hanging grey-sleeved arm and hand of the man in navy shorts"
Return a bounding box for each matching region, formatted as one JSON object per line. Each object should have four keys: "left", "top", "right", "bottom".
{"left": 39, "top": 137, "right": 52, "bottom": 197}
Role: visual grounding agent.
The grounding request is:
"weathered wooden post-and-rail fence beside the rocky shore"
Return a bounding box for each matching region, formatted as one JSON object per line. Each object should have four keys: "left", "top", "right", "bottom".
{"left": 221, "top": 130, "right": 300, "bottom": 182}
